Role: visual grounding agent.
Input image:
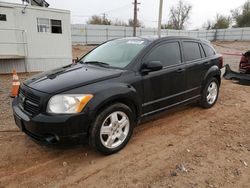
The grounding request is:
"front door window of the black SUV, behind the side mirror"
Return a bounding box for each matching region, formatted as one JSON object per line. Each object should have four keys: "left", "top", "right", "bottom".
{"left": 146, "top": 42, "right": 181, "bottom": 67}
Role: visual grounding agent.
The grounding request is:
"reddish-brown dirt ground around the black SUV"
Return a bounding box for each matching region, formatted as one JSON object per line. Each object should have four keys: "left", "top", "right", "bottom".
{"left": 0, "top": 42, "right": 250, "bottom": 188}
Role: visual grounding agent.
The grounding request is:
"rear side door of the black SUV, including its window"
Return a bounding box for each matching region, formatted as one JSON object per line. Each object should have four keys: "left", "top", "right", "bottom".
{"left": 182, "top": 40, "right": 207, "bottom": 98}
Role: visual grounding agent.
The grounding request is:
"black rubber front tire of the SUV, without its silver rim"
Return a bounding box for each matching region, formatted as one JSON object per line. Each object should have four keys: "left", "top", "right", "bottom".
{"left": 89, "top": 103, "right": 135, "bottom": 155}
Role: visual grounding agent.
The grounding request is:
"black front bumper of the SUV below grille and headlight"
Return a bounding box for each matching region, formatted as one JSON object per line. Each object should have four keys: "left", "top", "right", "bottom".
{"left": 12, "top": 98, "right": 91, "bottom": 144}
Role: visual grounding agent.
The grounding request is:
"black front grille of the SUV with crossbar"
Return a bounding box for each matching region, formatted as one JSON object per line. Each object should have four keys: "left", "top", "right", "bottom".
{"left": 19, "top": 88, "right": 40, "bottom": 116}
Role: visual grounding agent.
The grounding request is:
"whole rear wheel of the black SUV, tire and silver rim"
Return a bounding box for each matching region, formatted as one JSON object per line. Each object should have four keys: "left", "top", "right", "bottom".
{"left": 200, "top": 77, "right": 219, "bottom": 108}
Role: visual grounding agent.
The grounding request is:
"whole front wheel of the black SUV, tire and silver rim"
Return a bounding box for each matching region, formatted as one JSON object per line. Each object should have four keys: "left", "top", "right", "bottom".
{"left": 89, "top": 103, "right": 135, "bottom": 155}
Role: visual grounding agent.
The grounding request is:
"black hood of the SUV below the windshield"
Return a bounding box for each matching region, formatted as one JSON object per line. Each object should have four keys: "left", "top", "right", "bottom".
{"left": 24, "top": 64, "right": 123, "bottom": 94}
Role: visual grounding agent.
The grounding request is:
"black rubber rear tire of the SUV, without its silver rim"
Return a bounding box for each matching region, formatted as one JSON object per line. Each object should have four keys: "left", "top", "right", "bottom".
{"left": 200, "top": 78, "right": 220, "bottom": 108}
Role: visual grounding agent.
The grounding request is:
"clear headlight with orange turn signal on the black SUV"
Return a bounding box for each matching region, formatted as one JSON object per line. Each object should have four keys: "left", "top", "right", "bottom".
{"left": 47, "top": 94, "right": 93, "bottom": 114}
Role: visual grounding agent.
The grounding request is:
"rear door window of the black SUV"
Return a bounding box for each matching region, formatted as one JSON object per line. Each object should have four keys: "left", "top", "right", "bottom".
{"left": 183, "top": 42, "right": 201, "bottom": 61}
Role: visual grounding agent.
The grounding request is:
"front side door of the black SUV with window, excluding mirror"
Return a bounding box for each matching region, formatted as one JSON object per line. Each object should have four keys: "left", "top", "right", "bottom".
{"left": 142, "top": 41, "right": 186, "bottom": 115}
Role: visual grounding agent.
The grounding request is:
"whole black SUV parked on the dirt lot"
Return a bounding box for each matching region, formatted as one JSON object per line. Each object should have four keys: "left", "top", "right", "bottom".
{"left": 13, "top": 37, "right": 223, "bottom": 154}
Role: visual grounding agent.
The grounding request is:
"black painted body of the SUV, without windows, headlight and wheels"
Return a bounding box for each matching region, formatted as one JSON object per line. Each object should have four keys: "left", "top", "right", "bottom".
{"left": 13, "top": 37, "right": 222, "bottom": 142}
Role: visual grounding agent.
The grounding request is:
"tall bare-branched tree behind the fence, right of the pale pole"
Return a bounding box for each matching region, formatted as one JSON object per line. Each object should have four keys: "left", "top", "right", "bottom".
{"left": 168, "top": 0, "right": 192, "bottom": 30}
